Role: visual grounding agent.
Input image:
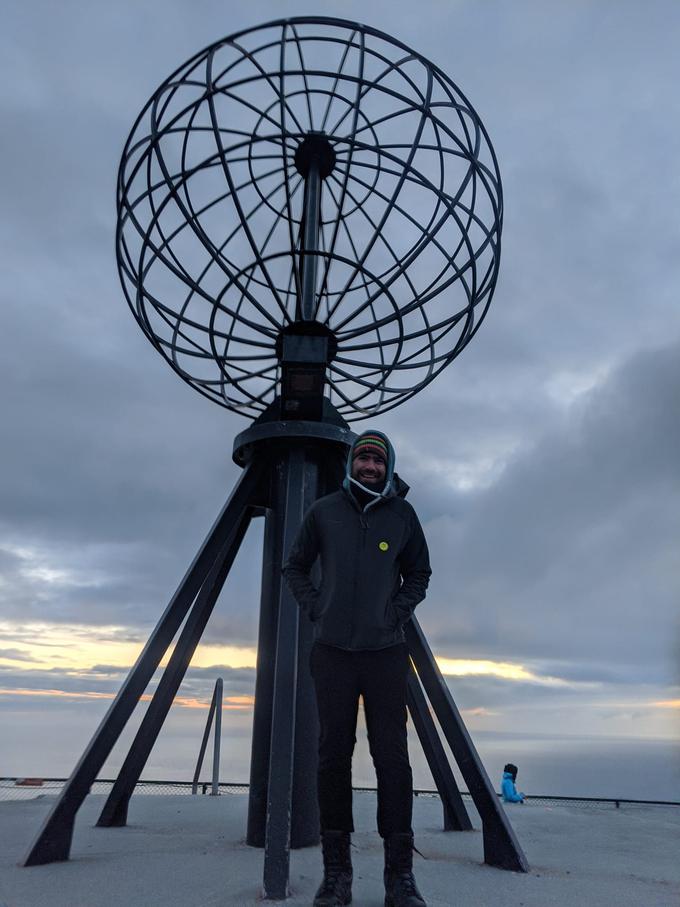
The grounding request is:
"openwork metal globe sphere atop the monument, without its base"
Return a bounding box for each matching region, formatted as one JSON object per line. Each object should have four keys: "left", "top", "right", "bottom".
{"left": 117, "top": 19, "right": 502, "bottom": 421}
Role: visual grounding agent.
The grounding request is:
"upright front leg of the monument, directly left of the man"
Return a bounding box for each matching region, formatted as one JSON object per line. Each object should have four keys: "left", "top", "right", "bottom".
{"left": 263, "top": 449, "right": 316, "bottom": 900}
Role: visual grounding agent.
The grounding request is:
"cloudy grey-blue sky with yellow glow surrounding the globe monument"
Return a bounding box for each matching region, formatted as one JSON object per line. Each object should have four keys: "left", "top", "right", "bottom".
{"left": 0, "top": 0, "right": 680, "bottom": 796}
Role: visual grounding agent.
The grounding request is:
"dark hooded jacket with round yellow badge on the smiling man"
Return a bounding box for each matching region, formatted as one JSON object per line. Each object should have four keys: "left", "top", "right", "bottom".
{"left": 283, "top": 438, "right": 431, "bottom": 651}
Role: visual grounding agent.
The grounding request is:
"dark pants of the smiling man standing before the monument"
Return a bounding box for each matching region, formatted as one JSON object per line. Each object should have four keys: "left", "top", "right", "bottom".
{"left": 310, "top": 643, "right": 413, "bottom": 838}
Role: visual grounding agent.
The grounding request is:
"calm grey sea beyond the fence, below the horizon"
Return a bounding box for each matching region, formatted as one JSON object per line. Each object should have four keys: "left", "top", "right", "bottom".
{"left": 0, "top": 709, "right": 680, "bottom": 802}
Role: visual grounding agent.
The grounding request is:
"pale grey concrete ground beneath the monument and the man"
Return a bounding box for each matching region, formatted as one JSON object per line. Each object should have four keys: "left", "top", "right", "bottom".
{"left": 0, "top": 793, "right": 680, "bottom": 907}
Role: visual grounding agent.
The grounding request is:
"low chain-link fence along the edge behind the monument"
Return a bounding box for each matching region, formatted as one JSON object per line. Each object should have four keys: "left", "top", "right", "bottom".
{"left": 0, "top": 778, "right": 680, "bottom": 809}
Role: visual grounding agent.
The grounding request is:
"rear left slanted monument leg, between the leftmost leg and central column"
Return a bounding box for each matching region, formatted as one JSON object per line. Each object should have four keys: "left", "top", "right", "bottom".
{"left": 97, "top": 508, "right": 251, "bottom": 827}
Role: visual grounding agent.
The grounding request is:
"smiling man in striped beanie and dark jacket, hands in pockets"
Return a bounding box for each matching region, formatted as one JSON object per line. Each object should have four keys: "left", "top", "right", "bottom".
{"left": 283, "top": 431, "right": 431, "bottom": 907}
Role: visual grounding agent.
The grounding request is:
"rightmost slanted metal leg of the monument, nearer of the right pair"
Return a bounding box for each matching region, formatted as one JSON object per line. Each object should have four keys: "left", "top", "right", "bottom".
{"left": 404, "top": 617, "right": 529, "bottom": 872}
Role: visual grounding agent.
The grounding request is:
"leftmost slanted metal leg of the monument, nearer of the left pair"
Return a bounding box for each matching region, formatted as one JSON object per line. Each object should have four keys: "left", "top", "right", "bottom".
{"left": 23, "top": 466, "right": 261, "bottom": 866}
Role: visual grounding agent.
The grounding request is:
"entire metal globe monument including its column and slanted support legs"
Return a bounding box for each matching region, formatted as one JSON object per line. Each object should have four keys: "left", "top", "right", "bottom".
{"left": 25, "top": 17, "right": 527, "bottom": 899}
